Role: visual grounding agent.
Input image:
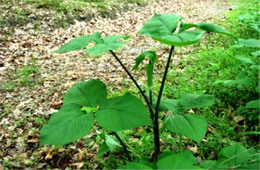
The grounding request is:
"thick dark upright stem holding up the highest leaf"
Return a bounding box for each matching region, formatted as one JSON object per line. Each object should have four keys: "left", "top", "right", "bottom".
{"left": 153, "top": 46, "right": 174, "bottom": 160}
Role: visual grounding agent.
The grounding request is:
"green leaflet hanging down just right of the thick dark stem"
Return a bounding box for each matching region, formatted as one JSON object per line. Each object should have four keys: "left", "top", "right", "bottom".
{"left": 164, "top": 114, "right": 207, "bottom": 143}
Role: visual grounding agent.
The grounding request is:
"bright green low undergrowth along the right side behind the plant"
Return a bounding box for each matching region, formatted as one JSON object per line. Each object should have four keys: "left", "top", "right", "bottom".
{"left": 165, "top": 0, "right": 260, "bottom": 159}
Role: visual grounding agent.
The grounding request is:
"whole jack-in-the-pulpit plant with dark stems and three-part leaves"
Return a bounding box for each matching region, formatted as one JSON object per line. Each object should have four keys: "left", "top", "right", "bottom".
{"left": 40, "top": 14, "right": 254, "bottom": 169}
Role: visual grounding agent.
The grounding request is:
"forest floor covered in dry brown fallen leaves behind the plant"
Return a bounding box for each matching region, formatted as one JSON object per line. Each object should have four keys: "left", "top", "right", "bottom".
{"left": 0, "top": 0, "right": 240, "bottom": 169}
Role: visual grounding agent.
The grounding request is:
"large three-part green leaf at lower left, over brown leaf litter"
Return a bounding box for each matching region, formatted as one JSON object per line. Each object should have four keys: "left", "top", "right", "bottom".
{"left": 40, "top": 80, "right": 152, "bottom": 145}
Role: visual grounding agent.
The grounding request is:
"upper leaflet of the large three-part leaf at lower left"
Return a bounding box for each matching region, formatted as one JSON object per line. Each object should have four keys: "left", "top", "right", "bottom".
{"left": 64, "top": 80, "right": 107, "bottom": 108}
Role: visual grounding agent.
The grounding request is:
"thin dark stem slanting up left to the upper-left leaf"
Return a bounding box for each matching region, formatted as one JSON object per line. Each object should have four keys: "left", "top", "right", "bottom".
{"left": 109, "top": 50, "right": 154, "bottom": 120}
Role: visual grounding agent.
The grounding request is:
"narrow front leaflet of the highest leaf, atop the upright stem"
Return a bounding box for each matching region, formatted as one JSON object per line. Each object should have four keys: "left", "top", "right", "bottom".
{"left": 152, "top": 31, "right": 205, "bottom": 46}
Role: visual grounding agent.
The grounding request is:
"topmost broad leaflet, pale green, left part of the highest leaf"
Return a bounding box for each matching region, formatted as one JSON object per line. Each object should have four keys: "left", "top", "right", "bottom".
{"left": 139, "top": 14, "right": 182, "bottom": 38}
